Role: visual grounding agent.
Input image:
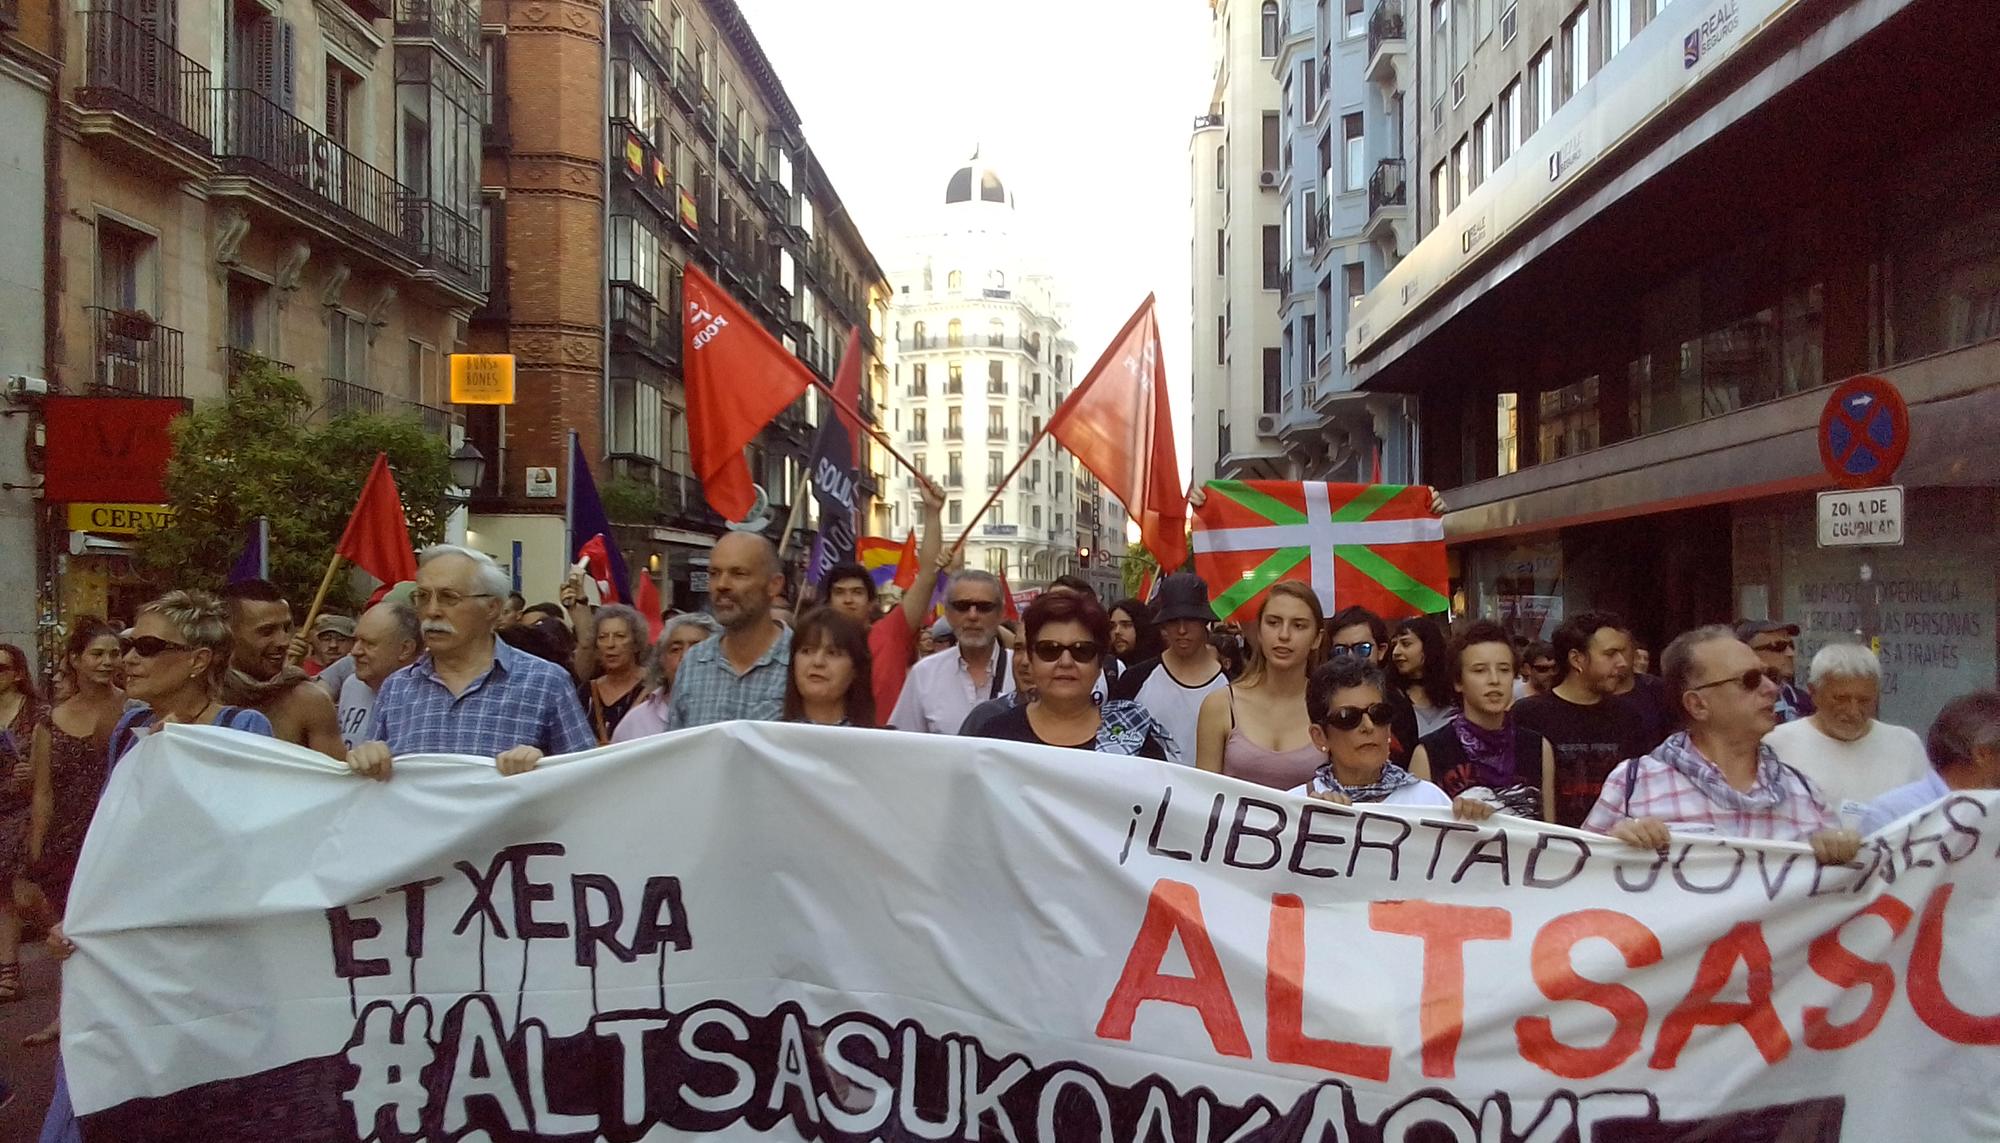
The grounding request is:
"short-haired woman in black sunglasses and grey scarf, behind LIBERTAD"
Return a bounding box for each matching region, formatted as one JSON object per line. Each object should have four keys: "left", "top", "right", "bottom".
{"left": 1294, "top": 655, "right": 1452, "bottom": 807}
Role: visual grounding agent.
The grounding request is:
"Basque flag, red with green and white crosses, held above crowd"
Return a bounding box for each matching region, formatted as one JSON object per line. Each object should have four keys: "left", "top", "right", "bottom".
{"left": 1194, "top": 480, "right": 1450, "bottom": 623}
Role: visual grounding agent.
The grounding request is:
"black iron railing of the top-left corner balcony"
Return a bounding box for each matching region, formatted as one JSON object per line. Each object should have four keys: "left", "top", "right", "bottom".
{"left": 76, "top": 10, "right": 216, "bottom": 154}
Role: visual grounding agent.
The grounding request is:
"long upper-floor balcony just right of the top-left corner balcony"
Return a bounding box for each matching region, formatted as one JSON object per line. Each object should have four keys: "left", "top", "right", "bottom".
{"left": 214, "top": 88, "right": 480, "bottom": 298}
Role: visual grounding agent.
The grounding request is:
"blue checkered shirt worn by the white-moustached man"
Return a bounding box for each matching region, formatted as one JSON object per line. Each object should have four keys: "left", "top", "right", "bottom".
{"left": 366, "top": 639, "right": 598, "bottom": 757}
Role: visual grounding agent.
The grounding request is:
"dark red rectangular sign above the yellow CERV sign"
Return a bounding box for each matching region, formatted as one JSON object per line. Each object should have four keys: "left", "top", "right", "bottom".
{"left": 42, "top": 398, "right": 188, "bottom": 504}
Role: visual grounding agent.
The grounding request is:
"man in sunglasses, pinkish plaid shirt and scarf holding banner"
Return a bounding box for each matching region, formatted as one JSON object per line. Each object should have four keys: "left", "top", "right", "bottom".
{"left": 1584, "top": 625, "right": 1862, "bottom": 865}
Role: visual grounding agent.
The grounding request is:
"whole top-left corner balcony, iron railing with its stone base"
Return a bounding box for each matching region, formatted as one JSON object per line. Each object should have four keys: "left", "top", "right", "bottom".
{"left": 76, "top": 10, "right": 216, "bottom": 180}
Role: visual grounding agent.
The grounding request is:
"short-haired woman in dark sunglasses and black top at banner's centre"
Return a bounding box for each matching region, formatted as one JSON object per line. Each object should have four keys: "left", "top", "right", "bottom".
{"left": 976, "top": 591, "right": 1174, "bottom": 761}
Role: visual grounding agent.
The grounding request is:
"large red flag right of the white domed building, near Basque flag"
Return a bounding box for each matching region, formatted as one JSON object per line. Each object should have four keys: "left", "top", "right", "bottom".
{"left": 1048, "top": 294, "right": 1188, "bottom": 568}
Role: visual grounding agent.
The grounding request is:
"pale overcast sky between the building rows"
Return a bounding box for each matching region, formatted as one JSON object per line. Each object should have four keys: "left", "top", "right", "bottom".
{"left": 738, "top": 0, "right": 1210, "bottom": 474}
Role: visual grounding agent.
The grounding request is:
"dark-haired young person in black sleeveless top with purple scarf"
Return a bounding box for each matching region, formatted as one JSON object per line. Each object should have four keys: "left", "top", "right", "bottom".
{"left": 1410, "top": 619, "right": 1556, "bottom": 821}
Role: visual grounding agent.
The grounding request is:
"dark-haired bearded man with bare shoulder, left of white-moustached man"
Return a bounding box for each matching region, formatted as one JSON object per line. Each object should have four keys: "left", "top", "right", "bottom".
{"left": 222, "top": 579, "right": 348, "bottom": 761}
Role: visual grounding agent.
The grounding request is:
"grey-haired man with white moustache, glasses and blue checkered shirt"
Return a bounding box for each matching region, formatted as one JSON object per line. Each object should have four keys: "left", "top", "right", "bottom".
{"left": 348, "top": 544, "right": 598, "bottom": 777}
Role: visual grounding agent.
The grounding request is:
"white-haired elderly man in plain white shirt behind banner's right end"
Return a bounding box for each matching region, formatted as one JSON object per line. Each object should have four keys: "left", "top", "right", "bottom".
{"left": 1764, "top": 643, "right": 1930, "bottom": 827}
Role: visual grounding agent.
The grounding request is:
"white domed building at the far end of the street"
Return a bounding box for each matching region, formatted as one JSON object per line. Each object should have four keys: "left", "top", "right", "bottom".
{"left": 884, "top": 156, "right": 1124, "bottom": 591}
